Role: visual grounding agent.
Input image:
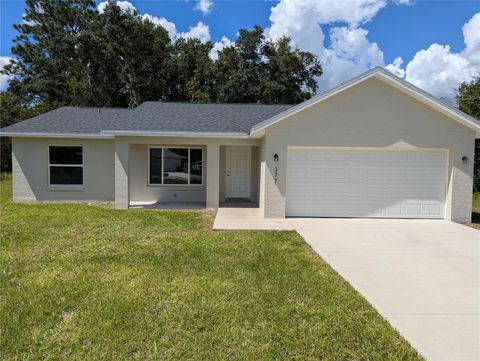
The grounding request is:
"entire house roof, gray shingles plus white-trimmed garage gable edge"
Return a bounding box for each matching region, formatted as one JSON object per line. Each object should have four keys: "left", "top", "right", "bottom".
{"left": 0, "top": 67, "right": 480, "bottom": 138}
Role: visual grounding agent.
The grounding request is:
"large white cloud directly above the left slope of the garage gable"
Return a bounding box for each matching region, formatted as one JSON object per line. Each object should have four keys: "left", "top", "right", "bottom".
{"left": 267, "top": 0, "right": 398, "bottom": 90}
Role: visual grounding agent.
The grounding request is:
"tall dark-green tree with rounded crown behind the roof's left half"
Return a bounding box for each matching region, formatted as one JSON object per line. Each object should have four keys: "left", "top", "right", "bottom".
{"left": 79, "top": 2, "right": 172, "bottom": 107}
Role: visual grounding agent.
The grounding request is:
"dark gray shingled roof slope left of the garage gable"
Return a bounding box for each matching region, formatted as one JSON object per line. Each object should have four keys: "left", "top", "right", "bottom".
{"left": 2, "top": 102, "right": 291, "bottom": 135}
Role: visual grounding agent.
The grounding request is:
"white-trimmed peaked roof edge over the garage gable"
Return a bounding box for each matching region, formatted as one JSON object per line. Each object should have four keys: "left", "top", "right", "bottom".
{"left": 251, "top": 66, "right": 480, "bottom": 137}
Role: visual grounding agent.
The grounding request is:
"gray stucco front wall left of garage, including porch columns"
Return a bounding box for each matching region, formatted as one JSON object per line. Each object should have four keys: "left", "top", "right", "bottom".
{"left": 12, "top": 137, "right": 260, "bottom": 208}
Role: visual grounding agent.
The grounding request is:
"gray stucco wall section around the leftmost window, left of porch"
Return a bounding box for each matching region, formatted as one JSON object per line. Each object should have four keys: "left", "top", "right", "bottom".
{"left": 12, "top": 138, "right": 114, "bottom": 202}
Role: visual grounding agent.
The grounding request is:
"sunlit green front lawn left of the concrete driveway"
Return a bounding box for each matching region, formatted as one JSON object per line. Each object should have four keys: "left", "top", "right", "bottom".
{"left": 0, "top": 177, "right": 420, "bottom": 360}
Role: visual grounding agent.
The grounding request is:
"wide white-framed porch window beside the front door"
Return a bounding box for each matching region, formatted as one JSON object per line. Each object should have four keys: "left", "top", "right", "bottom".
{"left": 149, "top": 147, "right": 202, "bottom": 185}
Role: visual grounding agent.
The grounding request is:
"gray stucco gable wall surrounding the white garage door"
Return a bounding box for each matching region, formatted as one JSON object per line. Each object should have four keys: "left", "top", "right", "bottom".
{"left": 260, "top": 78, "right": 475, "bottom": 221}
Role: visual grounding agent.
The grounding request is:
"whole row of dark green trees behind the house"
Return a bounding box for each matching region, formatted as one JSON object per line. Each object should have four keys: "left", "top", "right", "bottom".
{"left": 4, "top": 0, "right": 322, "bottom": 108}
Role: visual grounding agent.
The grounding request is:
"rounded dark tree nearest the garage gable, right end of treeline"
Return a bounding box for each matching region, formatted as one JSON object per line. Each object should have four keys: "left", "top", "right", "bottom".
{"left": 215, "top": 26, "right": 322, "bottom": 103}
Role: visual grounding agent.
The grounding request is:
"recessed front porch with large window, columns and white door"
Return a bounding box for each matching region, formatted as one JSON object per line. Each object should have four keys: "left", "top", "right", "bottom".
{"left": 115, "top": 137, "right": 261, "bottom": 209}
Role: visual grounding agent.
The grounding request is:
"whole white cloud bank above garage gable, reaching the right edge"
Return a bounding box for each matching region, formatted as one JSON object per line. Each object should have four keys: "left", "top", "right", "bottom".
{"left": 267, "top": 0, "right": 480, "bottom": 99}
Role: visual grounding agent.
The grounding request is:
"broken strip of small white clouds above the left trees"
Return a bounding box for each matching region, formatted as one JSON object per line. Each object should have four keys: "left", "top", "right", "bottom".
{"left": 97, "top": 1, "right": 213, "bottom": 42}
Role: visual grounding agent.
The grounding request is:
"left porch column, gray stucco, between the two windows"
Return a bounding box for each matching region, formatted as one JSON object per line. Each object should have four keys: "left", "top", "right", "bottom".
{"left": 115, "top": 139, "right": 130, "bottom": 209}
